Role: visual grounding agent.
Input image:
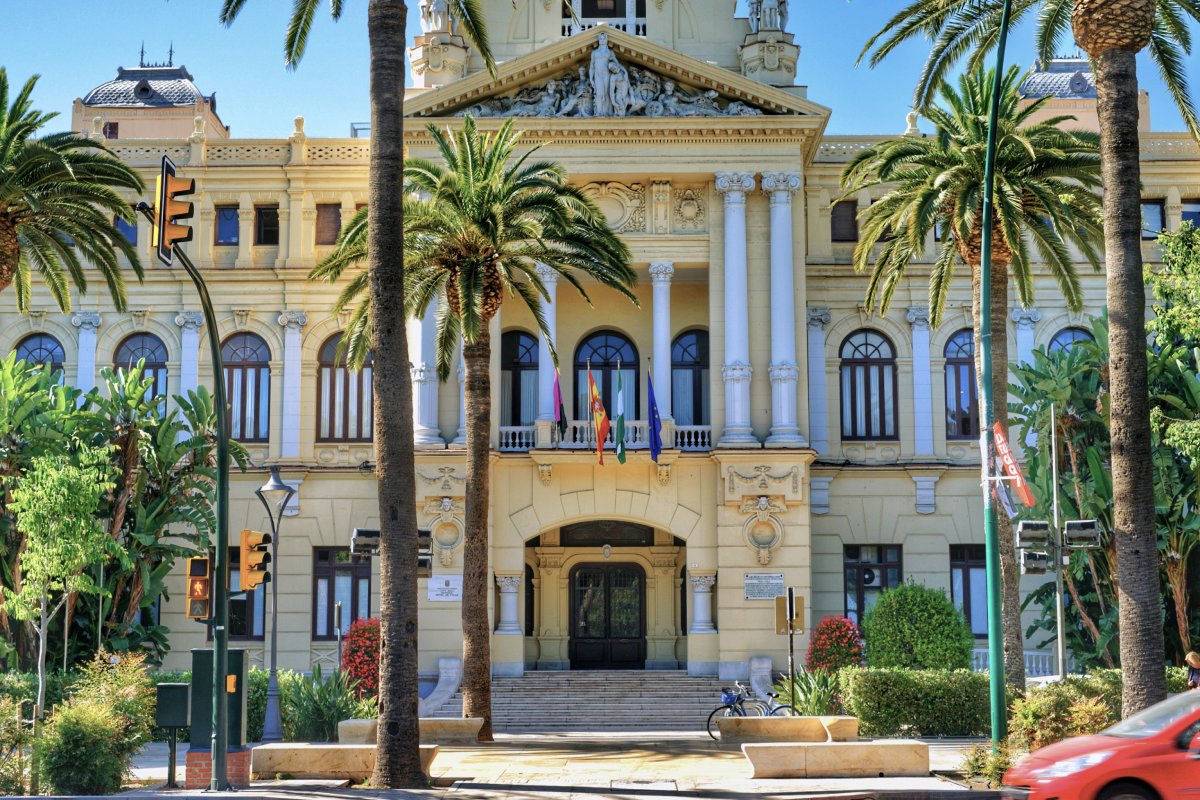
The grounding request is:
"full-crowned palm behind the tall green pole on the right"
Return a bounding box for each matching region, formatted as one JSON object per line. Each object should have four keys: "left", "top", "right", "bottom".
{"left": 841, "top": 67, "right": 1100, "bottom": 688}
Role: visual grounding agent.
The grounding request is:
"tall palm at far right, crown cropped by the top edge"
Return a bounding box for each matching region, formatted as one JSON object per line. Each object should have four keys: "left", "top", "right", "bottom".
{"left": 860, "top": 0, "right": 1200, "bottom": 715}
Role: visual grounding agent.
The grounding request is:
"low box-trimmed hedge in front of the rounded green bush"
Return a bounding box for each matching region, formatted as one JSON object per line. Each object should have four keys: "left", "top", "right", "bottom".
{"left": 838, "top": 667, "right": 991, "bottom": 736}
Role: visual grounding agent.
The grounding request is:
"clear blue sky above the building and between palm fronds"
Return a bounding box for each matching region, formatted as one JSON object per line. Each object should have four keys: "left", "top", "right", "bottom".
{"left": 0, "top": 0, "right": 1200, "bottom": 138}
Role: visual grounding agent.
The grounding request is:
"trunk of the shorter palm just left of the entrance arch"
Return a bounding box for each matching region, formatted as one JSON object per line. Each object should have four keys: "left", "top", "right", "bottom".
{"left": 462, "top": 328, "right": 492, "bottom": 741}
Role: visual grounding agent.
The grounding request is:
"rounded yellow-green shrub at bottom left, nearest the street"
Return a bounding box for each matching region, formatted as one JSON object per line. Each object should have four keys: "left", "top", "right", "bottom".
{"left": 34, "top": 700, "right": 133, "bottom": 794}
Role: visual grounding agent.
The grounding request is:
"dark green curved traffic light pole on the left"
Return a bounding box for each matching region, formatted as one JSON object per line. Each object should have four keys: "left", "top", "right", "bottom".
{"left": 138, "top": 203, "right": 231, "bottom": 792}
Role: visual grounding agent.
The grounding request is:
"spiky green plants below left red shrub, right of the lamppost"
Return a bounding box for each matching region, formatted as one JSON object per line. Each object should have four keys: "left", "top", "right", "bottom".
{"left": 280, "top": 666, "right": 379, "bottom": 741}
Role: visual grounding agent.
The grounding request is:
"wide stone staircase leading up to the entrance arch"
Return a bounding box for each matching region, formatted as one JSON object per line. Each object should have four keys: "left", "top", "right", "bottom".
{"left": 436, "top": 669, "right": 730, "bottom": 733}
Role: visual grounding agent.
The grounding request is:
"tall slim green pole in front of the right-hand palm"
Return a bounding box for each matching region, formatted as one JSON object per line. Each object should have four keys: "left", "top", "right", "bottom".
{"left": 979, "top": 0, "right": 1013, "bottom": 750}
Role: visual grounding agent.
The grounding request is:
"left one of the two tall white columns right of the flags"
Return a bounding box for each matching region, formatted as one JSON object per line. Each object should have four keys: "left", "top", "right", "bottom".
{"left": 716, "top": 173, "right": 758, "bottom": 447}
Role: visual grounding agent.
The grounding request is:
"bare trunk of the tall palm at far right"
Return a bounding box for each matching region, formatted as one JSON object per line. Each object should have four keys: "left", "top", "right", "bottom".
{"left": 1092, "top": 48, "right": 1166, "bottom": 716}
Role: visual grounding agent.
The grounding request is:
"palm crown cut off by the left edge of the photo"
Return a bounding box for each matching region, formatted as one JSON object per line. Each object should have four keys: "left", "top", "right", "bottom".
{"left": 0, "top": 67, "right": 144, "bottom": 313}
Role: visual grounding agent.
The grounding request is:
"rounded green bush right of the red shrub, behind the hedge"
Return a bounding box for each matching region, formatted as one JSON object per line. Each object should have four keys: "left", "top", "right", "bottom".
{"left": 863, "top": 583, "right": 974, "bottom": 669}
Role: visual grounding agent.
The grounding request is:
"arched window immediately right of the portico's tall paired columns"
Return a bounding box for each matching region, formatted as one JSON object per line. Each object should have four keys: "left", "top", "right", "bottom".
{"left": 840, "top": 329, "right": 898, "bottom": 439}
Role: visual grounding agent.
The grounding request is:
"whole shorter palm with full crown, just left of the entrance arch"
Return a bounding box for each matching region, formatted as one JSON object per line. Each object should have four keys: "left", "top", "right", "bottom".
{"left": 313, "top": 116, "right": 637, "bottom": 741}
